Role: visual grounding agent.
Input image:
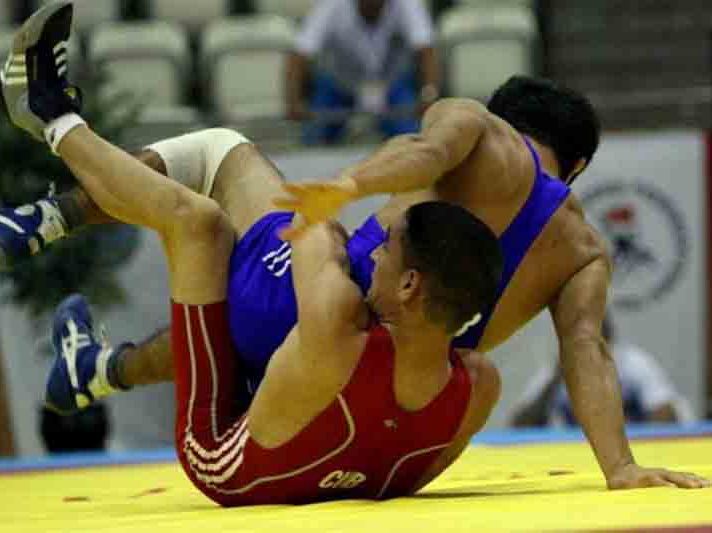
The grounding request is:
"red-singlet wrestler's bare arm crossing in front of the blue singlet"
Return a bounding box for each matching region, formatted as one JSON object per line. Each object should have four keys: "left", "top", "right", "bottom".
{"left": 250, "top": 220, "right": 365, "bottom": 440}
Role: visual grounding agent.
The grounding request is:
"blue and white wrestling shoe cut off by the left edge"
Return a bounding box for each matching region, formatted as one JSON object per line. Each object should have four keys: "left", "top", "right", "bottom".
{"left": 0, "top": 195, "right": 67, "bottom": 272}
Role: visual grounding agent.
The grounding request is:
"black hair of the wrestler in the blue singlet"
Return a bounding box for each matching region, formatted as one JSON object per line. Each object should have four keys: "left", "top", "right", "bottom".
{"left": 487, "top": 76, "right": 601, "bottom": 184}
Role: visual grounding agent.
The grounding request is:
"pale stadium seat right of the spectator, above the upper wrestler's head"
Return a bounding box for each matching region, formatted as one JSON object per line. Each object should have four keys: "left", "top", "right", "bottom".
{"left": 439, "top": 5, "right": 537, "bottom": 99}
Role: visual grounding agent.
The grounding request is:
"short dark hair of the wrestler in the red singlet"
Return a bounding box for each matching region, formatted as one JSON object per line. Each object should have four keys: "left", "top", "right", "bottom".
{"left": 402, "top": 202, "right": 503, "bottom": 334}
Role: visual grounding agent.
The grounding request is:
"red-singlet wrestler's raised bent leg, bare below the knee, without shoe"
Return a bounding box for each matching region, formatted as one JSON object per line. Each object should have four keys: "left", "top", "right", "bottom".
{"left": 54, "top": 129, "right": 258, "bottom": 497}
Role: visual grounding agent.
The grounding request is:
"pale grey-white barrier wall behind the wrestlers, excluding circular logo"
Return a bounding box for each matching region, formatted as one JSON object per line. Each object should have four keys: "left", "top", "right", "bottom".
{"left": 0, "top": 132, "right": 706, "bottom": 455}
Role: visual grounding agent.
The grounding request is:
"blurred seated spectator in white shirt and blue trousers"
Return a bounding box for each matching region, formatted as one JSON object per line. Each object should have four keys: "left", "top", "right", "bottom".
{"left": 286, "top": 0, "right": 440, "bottom": 144}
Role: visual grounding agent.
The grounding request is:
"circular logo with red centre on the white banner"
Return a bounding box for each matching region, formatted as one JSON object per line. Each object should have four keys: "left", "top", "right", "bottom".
{"left": 581, "top": 181, "right": 689, "bottom": 310}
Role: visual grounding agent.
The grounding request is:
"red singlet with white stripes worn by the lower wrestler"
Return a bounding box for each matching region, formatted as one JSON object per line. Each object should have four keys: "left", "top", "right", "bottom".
{"left": 173, "top": 303, "right": 471, "bottom": 506}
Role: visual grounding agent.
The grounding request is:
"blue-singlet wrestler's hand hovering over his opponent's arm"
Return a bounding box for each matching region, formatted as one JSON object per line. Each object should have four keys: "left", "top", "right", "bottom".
{"left": 274, "top": 178, "right": 358, "bottom": 241}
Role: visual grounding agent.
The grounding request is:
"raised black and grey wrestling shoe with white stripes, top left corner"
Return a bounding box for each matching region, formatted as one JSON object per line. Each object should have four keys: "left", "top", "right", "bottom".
{"left": 0, "top": 1, "right": 81, "bottom": 144}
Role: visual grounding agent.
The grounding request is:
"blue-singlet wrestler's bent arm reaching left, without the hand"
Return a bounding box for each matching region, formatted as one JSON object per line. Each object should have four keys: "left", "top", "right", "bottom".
{"left": 343, "top": 98, "right": 488, "bottom": 197}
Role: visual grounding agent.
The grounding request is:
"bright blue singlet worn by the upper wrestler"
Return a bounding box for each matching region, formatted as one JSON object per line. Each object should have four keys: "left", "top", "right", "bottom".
{"left": 228, "top": 139, "right": 570, "bottom": 392}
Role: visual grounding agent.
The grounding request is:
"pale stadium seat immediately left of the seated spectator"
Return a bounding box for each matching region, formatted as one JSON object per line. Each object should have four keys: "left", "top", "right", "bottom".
{"left": 201, "top": 15, "right": 295, "bottom": 118}
